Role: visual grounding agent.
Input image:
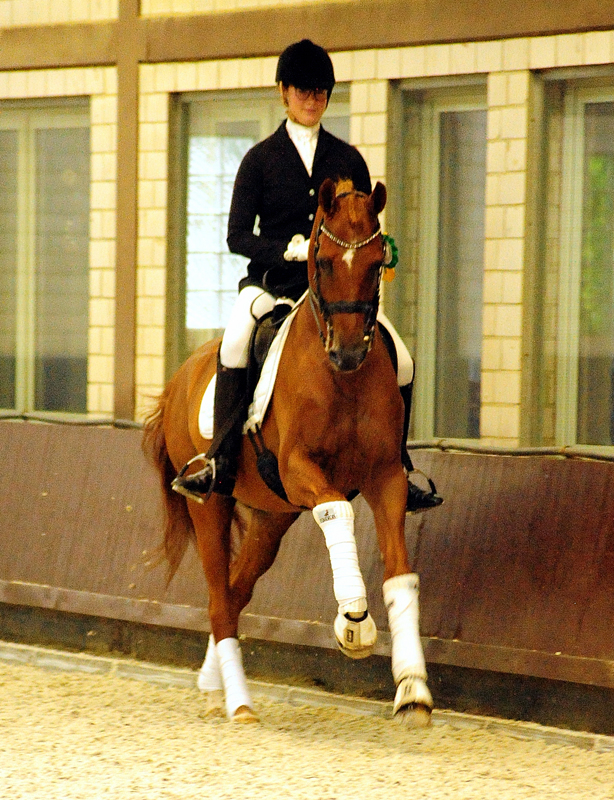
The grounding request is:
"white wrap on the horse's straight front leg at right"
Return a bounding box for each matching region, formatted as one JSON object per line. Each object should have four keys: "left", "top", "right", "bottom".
{"left": 383, "top": 572, "right": 426, "bottom": 685}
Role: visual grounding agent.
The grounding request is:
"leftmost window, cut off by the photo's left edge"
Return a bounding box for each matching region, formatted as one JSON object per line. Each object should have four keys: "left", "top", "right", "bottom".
{"left": 0, "top": 105, "right": 90, "bottom": 412}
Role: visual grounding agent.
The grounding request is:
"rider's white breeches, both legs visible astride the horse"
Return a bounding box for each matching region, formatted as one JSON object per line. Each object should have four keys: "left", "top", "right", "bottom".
{"left": 220, "top": 286, "right": 414, "bottom": 386}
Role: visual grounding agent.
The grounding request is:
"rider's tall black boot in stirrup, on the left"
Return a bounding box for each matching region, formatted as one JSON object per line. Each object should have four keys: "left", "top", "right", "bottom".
{"left": 172, "top": 355, "right": 247, "bottom": 501}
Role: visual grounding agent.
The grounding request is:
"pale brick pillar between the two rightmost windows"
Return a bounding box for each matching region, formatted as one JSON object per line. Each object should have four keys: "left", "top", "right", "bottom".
{"left": 481, "top": 70, "right": 536, "bottom": 447}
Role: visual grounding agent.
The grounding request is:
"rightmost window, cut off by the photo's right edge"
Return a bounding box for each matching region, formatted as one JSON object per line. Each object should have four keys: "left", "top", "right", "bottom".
{"left": 556, "top": 86, "right": 614, "bottom": 445}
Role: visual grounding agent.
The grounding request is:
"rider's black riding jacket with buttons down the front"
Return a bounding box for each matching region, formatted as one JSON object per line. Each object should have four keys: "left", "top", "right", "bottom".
{"left": 227, "top": 122, "right": 371, "bottom": 299}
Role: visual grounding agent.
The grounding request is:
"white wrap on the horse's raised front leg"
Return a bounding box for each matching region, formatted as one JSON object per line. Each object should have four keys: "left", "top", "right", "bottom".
{"left": 313, "top": 500, "right": 367, "bottom": 614}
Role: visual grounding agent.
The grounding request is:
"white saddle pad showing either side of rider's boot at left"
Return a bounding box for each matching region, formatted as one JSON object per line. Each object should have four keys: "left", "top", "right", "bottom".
{"left": 198, "top": 292, "right": 307, "bottom": 439}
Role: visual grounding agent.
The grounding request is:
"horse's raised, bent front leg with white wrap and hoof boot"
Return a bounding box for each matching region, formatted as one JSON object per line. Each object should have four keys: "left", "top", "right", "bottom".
{"left": 284, "top": 450, "right": 377, "bottom": 658}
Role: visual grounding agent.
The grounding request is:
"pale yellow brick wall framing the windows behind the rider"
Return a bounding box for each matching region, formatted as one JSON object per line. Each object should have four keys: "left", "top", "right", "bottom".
{"left": 0, "top": 0, "right": 614, "bottom": 438}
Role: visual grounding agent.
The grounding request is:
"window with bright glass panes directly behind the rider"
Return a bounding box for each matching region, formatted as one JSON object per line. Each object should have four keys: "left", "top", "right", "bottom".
{"left": 169, "top": 85, "right": 349, "bottom": 369}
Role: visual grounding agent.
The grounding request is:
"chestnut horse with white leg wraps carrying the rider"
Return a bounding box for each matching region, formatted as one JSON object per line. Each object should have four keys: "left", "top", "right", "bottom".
{"left": 143, "top": 179, "right": 433, "bottom": 727}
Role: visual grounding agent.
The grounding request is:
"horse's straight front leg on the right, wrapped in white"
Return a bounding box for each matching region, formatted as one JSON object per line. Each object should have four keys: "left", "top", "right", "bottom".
{"left": 363, "top": 470, "right": 433, "bottom": 727}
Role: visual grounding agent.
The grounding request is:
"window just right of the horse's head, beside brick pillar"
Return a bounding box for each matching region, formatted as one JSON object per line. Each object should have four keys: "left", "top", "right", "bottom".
{"left": 386, "top": 89, "right": 486, "bottom": 438}
